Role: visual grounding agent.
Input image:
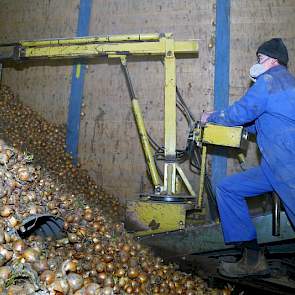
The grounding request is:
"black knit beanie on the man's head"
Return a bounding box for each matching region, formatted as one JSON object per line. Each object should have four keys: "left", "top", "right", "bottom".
{"left": 256, "top": 38, "right": 289, "bottom": 66}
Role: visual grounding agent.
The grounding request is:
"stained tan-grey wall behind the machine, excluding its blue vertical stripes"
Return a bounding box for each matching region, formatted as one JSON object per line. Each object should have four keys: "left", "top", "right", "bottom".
{"left": 0, "top": 0, "right": 295, "bottom": 201}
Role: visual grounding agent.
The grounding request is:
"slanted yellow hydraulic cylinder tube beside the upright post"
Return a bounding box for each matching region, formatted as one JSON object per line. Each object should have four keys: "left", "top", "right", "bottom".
{"left": 132, "top": 99, "right": 161, "bottom": 187}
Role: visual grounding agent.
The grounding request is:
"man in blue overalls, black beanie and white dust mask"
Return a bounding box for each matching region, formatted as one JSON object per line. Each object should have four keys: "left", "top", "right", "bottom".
{"left": 203, "top": 38, "right": 295, "bottom": 277}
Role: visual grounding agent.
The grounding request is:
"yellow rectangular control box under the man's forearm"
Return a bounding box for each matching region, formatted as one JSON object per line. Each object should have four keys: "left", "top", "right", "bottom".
{"left": 202, "top": 124, "right": 243, "bottom": 148}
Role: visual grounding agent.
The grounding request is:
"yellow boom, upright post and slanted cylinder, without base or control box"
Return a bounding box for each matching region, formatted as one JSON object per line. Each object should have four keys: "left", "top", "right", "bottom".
{"left": 0, "top": 33, "right": 198, "bottom": 197}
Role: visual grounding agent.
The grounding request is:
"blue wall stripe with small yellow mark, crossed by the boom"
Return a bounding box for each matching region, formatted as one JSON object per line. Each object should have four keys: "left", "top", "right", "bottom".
{"left": 66, "top": 0, "right": 92, "bottom": 164}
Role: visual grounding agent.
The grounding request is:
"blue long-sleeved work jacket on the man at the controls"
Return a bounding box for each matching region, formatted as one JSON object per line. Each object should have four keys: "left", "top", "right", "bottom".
{"left": 208, "top": 65, "right": 295, "bottom": 225}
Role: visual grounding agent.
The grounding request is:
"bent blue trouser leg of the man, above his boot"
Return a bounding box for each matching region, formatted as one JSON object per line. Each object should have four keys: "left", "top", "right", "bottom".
{"left": 216, "top": 167, "right": 274, "bottom": 244}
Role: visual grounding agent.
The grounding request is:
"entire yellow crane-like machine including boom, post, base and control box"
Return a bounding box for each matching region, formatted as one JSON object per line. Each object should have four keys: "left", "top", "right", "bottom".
{"left": 0, "top": 33, "right": 252, "bottom": 235}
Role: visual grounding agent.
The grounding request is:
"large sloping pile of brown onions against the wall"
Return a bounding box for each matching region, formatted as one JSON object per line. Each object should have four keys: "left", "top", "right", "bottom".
{"left": 0, "top": 87, "right": 229, "bottom": 295}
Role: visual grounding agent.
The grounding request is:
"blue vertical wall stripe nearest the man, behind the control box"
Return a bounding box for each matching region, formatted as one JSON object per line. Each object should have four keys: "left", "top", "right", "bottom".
{"left": 212, "top": 0, "right": 230, "bottom": 186}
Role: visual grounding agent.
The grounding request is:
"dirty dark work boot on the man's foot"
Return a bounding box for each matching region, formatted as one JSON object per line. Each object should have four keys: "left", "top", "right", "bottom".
{"left": 218, "top": 248, "right": 270, "bottom": 278}
